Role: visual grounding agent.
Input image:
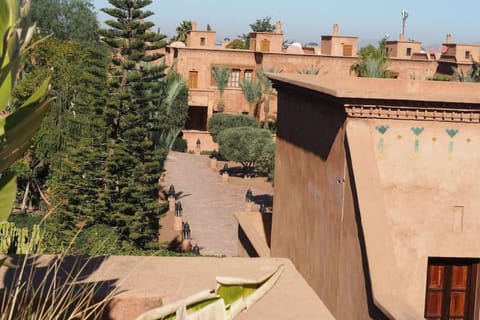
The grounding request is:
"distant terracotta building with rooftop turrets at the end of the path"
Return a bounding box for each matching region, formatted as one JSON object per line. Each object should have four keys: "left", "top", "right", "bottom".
{"left": 166, "top": 22, "right": 480, "bottom": 151}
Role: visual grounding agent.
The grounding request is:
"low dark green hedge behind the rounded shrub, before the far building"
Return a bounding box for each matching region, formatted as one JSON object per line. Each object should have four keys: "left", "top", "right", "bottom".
{"left": 207, "top": 113, "right": 259, "bottom": 142}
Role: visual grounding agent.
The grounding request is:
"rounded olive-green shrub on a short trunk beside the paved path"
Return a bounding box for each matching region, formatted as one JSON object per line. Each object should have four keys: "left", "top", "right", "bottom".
{"left": 217, "top": 127, "right": 272, "bottom": 175}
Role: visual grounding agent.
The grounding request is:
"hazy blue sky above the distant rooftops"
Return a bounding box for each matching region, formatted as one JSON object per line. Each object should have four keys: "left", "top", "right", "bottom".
{"left": 93, "top": 0, "right": 480, "bottom": 49}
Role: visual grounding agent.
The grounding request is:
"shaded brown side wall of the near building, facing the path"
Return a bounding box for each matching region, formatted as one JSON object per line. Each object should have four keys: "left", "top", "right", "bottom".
{"left": 271, "top": 86, "right": 369, "bottom": 319}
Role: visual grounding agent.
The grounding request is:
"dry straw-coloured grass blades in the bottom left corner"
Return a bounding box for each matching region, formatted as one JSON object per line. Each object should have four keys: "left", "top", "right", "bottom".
{"left": 0, "top": 253, "right": 118, "bottom": 320}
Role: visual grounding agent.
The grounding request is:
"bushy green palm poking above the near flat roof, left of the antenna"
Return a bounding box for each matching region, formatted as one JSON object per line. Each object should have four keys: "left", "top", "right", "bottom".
{"left": 350, "top": 39, "right": 393, "bottom": 78}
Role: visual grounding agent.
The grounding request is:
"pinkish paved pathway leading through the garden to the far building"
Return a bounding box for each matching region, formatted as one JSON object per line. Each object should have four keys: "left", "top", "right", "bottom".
{"left": 160, "top": 151, "right": 271, "bottom": 256}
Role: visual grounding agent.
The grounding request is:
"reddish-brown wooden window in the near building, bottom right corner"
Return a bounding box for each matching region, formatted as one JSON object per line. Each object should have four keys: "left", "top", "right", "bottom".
{"left": 425, "top": 259, "right": 478, "bottom": 320}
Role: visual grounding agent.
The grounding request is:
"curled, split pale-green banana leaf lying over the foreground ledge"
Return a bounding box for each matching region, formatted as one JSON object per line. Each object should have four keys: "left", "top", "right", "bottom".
{"left": 137, "top": 265, "right": 284, "bottom": 320}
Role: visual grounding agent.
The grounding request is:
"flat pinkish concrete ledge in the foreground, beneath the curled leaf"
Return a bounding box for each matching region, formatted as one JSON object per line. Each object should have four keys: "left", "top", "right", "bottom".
{"left": 0, "top": 255, "right": 334, "bottom": 320}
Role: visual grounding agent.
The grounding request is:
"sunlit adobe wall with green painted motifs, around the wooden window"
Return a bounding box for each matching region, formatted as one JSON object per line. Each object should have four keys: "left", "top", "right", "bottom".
{"left": 344, "top": 119, "right": 480, "bottom": 315}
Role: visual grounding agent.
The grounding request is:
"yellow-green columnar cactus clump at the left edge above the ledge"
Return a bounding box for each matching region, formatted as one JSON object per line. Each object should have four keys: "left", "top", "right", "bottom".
{"left": 0, "top": 221, "right": 43, "bottom": 254}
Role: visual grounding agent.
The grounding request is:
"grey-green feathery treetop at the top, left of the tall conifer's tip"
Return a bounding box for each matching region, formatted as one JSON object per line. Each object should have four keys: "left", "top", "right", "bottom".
{"left": 32, "top": 0, "right": 98, "bottom": 42}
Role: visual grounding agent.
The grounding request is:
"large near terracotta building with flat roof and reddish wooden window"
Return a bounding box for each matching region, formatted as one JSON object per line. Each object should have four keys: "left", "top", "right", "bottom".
{"left": 260, "top": 74, "right": 480, "bottom": 319}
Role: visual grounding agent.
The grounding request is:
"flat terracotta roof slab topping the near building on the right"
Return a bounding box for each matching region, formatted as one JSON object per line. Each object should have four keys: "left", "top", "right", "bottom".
{"left": 266, "top": 73, "right": 480, "bottom": 104}
